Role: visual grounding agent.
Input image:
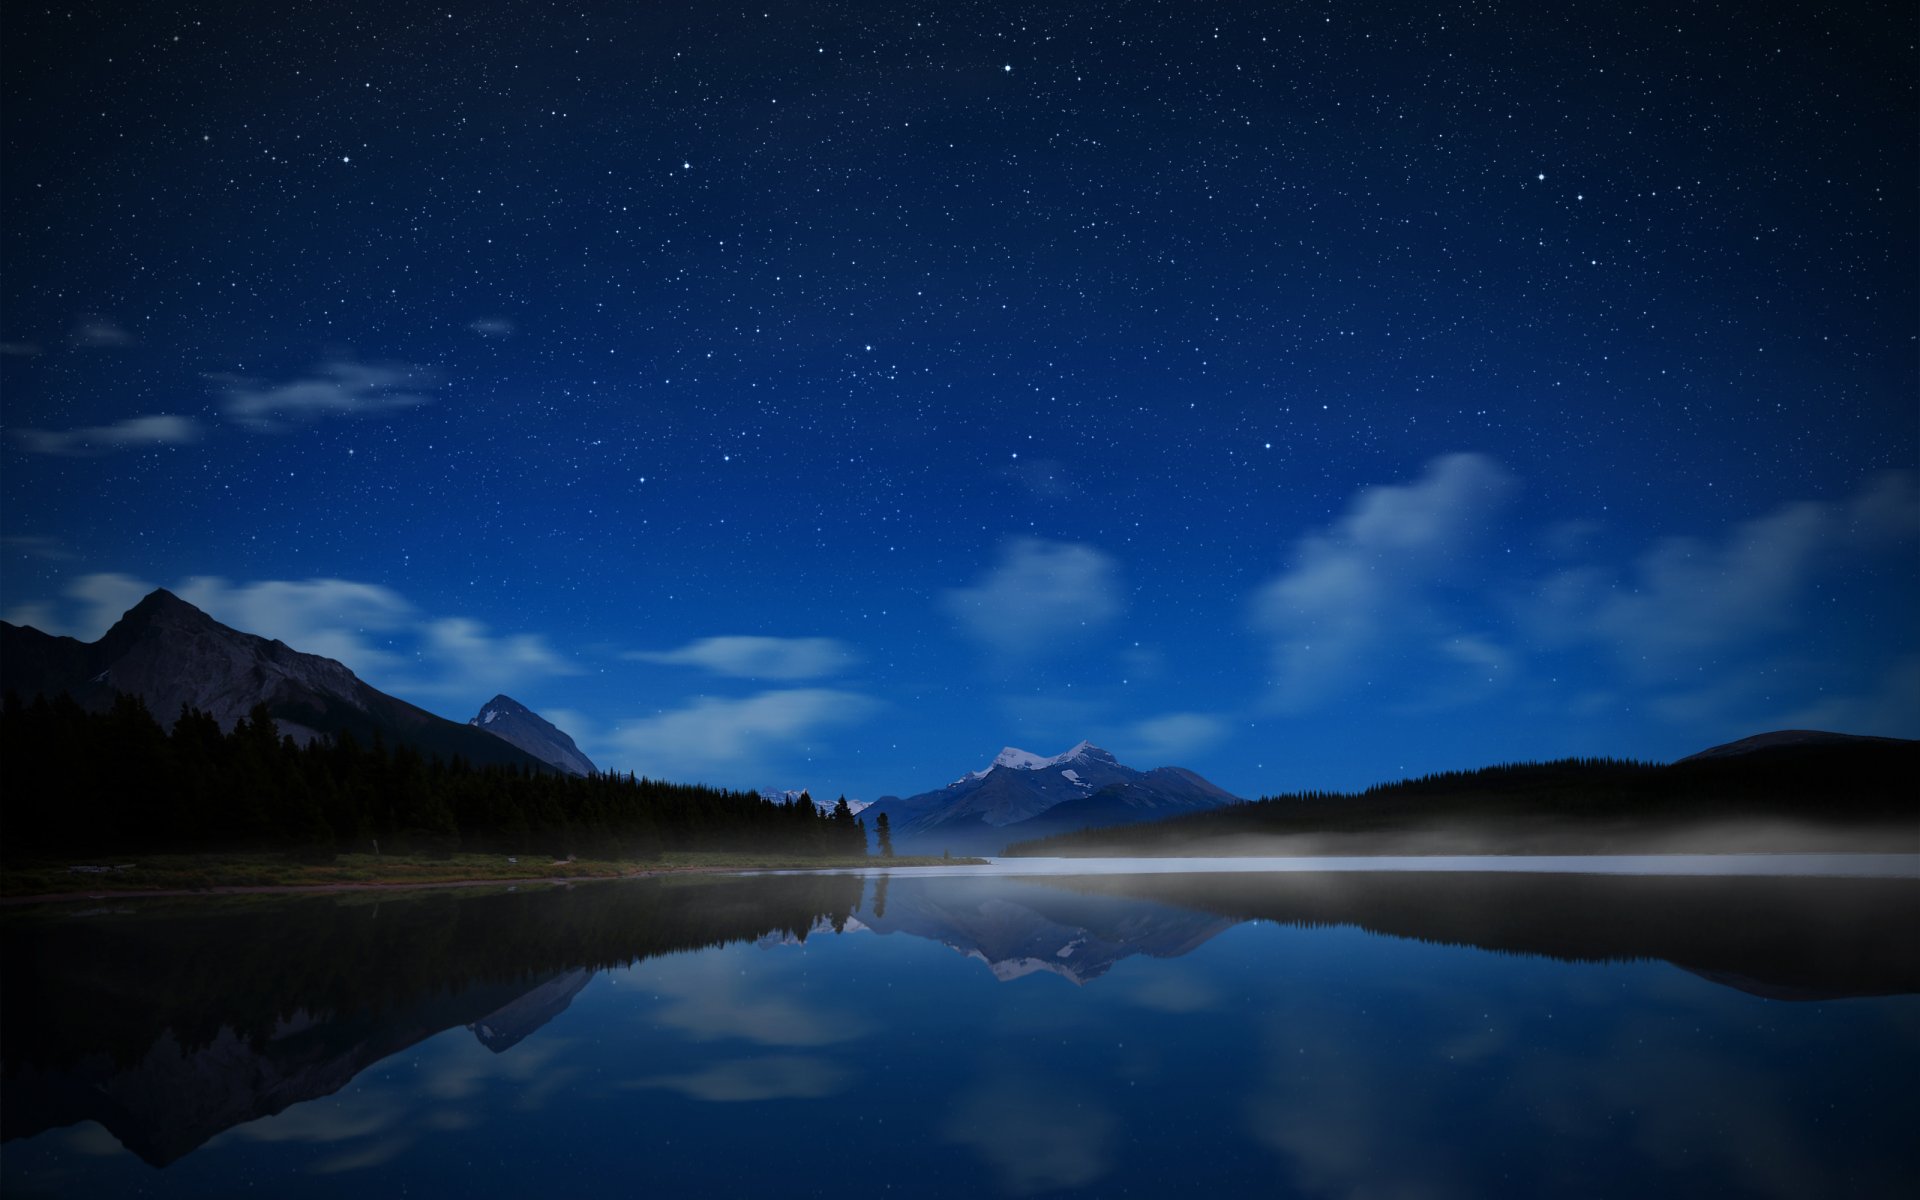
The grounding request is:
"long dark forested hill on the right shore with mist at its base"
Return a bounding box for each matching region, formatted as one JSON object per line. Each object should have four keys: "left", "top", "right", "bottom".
{"left": 1008, "top": 737, "right": 1920, "bottom": 854}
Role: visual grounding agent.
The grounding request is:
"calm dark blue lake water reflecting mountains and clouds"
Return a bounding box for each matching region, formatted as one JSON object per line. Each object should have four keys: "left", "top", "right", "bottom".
{"left": 0, "top": 872, "right": 1920, "bottom": 1198}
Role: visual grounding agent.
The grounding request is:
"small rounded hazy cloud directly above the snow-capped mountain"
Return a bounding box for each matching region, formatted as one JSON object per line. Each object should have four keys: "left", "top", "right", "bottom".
{"left": 941, "top": 538, "right": 1123, "bottom": 660}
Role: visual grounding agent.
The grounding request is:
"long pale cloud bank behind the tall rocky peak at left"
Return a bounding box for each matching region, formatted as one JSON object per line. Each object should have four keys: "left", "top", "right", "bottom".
{"left": 8, "top": 572, "right": 578, "bottom": 707}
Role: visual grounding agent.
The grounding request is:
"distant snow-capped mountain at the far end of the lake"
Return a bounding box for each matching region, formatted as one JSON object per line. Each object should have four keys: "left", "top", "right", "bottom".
{"left": 866, "top": 741, "right": 1238, "bottom": 854}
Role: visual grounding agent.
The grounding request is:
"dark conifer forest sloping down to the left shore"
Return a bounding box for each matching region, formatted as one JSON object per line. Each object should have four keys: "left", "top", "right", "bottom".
{"left": 0, "top": 693, "right": 866, "bottom": 862}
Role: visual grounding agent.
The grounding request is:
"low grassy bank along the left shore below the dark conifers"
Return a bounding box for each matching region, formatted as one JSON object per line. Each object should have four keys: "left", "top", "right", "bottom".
{"left": 0, "top": 851, "right": 983, "bottom": 897}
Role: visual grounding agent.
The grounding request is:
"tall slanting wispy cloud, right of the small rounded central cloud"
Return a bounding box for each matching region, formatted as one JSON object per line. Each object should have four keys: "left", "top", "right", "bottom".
{"left": 1254, "top": 453, "right": 1513, "bottom": 710}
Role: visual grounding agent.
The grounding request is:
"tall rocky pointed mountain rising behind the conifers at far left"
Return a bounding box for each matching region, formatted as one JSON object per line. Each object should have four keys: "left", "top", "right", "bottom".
{"left": 0, "top": 588, "right": 545, "bottom": 766}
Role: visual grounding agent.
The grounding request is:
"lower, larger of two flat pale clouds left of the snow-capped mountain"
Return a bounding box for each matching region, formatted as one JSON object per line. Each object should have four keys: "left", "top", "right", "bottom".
{"left": 605, "top": 687, "right": 879, "bottom": 778}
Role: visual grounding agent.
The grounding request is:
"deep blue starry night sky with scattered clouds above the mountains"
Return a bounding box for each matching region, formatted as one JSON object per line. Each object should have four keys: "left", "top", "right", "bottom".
{"left": 0, "top": 0, "right": 1920, "bottom": 799}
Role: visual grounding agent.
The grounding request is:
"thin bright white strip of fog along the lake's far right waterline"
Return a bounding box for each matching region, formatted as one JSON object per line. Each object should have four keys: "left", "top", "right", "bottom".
{"left": 821, "top": 854, "right": 1920, "bottom": 879}
